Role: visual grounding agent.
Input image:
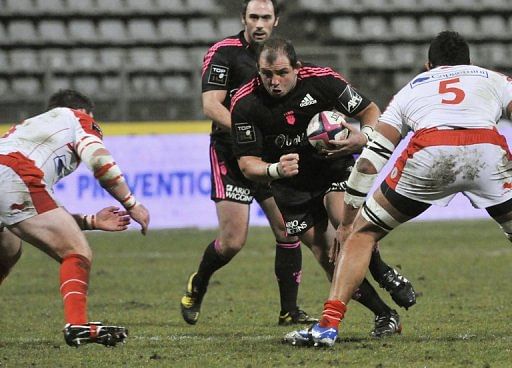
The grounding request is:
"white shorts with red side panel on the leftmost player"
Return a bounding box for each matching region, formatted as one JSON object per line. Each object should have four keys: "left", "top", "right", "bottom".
{"left": 0, "top": 152, "right": 58, "bottom": 226}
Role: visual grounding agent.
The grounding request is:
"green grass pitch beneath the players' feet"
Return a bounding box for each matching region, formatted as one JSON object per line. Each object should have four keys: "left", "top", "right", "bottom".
{"left": 0, "top": 221, "right": 512, "bottom": 368}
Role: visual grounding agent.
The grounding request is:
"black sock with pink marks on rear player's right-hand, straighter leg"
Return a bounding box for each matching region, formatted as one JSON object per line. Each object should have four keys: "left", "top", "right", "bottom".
{"left": 274, "top": 241, "right": 302, "bottom": 314}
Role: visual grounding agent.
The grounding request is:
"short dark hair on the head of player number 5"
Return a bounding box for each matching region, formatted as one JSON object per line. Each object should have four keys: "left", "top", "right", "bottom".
{"left": 428, "top": 31, "right": 470, "bottom": 68}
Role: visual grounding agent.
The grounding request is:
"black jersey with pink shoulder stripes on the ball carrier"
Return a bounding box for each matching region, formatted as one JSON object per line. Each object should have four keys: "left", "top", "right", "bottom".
{"left": 231, "top": 64, "right": 371, "bottom": 189}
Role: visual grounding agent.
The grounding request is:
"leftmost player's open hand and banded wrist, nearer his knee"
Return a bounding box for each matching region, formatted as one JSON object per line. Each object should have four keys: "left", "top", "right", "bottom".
{"left": 72, "top": 206, "right": 130, "bottom": 231}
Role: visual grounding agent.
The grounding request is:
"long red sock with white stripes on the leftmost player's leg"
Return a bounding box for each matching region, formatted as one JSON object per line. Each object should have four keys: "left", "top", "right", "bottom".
{"left": 60, "top": 254, "right": 91, "bottom": 324}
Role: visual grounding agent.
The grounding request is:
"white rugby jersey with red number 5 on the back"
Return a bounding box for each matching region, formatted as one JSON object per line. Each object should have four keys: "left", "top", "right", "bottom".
{"left": 379, "top": 65, "right": 512, "bottom": 135}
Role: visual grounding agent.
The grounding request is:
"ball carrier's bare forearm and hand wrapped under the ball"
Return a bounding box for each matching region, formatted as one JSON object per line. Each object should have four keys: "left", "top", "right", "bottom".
{"left": 325, "top": 102, "right": 381, "bottom": 156}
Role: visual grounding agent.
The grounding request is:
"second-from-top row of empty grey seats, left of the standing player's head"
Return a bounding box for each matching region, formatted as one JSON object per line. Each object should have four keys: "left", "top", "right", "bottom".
{"left": 0, "top": 18, "right": 242, "bottom": 44}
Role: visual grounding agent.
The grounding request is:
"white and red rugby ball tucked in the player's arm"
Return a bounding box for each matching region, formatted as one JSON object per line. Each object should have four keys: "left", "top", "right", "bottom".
{"left": 306, "top": 111, "right": 350, "bottom": 150}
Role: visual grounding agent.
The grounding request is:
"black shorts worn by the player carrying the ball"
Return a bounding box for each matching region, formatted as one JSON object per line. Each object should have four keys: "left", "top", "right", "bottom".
{"left": 272, "top": 156, "right": 353, "bottom": 235}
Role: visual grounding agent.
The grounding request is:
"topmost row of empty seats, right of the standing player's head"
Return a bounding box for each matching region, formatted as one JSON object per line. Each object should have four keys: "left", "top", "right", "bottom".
{"left": 298, "top": 0, "right": 510, "bottom": 13}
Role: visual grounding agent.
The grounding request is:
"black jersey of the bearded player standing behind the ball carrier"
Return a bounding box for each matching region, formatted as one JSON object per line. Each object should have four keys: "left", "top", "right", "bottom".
{"left": 201, "top": 31, "right": 258, "bottom": 142}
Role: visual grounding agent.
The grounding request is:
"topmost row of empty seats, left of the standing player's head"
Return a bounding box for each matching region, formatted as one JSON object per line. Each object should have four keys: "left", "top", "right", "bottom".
{"left": 4, "top": 0, "right": 222, "bottom": 15}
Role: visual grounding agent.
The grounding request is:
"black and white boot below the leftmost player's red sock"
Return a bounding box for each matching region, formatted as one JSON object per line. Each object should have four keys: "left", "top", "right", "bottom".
{"left": 63, "top": 322, "right": 128, "bottom": 348}
